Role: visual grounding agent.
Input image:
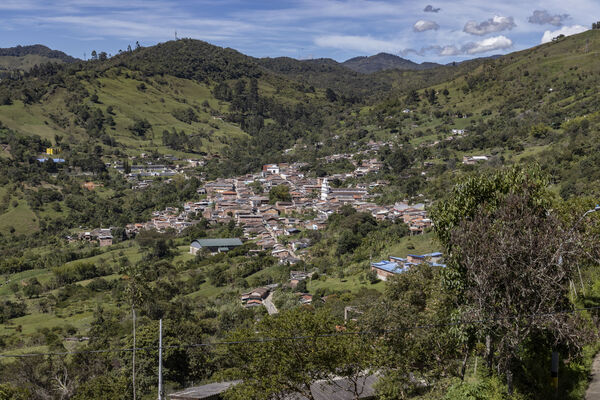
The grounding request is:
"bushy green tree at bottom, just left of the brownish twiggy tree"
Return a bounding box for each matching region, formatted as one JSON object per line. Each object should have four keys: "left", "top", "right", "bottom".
{"left": 357, "top": 264, "right": 460, "bottom": 399}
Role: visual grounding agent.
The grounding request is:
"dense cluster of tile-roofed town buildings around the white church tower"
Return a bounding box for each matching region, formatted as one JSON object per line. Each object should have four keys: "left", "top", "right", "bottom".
{"left": 117, "top": 160, "right": 431, "bottom": 265}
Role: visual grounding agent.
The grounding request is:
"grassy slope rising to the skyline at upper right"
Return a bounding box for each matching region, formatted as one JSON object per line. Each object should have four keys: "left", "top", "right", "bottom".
{"left": 361, "top": 30, "right": 600, "bottom": 155}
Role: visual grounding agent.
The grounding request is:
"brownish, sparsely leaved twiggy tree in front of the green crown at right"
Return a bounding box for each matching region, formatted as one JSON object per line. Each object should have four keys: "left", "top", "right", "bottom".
{"left": 451, "top": 194, "right": 585, "bottom": 384}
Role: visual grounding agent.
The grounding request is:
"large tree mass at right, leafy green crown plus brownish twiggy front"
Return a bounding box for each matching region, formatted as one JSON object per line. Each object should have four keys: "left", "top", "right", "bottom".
{"left": 432, "top": 167, "right": 598, "bottom": 391}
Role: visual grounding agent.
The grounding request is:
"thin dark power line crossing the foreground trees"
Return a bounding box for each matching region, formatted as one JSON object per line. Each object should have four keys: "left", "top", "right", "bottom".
{"left": 0, "top": 306, "right": 600, "bottom": 358}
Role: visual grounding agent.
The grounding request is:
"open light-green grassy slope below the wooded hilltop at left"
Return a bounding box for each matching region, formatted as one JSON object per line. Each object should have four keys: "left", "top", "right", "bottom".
{"left": 0, "top": 67, "right": 251, "bottom": 156}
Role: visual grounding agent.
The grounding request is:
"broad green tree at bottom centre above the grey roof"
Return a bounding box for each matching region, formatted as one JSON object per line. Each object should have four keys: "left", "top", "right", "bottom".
{"left": 226, "top": 308, "right": 377, "bottom": 400}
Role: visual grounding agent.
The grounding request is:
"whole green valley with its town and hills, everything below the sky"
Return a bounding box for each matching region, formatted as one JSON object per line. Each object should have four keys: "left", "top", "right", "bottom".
{"left": 0, "top": 29, "right": 600, "bottom": 400}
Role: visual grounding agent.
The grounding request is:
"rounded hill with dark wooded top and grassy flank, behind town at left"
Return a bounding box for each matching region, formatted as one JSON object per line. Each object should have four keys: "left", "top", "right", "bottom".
{"left": 0, "top": 39, "right": 459, "bottom": 172}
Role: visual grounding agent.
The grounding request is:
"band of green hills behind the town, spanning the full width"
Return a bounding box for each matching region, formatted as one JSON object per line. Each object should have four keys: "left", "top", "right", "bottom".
{"left": 0, "top": 30, "right": 600, "bottom": 183}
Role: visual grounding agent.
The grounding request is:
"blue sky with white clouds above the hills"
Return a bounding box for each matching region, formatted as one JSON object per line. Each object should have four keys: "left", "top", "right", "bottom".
{"left": 0, "top": 0, "right": 600, "bottom": 62}
